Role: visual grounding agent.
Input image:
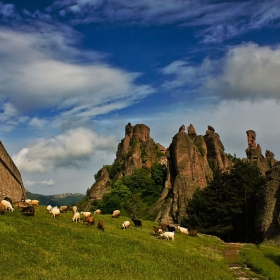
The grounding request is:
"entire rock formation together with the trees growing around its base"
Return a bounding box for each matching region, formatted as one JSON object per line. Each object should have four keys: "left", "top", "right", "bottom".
{"left": 80, "top": 123, "right": 280, "bottom": 243}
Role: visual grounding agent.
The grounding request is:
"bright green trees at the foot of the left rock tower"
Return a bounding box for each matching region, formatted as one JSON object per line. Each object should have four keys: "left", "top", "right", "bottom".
{"left": 93, "top": 163, "right": 166, "bottom": 219}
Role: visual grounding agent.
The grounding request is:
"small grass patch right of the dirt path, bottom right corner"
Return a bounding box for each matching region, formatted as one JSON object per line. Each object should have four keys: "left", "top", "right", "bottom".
{"left": 240, "top": 243, "right": 280, "bottom": 280}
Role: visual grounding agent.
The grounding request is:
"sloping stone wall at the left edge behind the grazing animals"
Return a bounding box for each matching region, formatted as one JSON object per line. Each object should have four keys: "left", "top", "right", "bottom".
{"left": 0, "top": 141, "right": 26, "bottom": 201}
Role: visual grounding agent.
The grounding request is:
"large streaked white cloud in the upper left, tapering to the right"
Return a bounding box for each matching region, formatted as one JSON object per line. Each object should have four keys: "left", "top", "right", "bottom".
{"left": 0, "top": 25, "right": 153, "bottom": 130}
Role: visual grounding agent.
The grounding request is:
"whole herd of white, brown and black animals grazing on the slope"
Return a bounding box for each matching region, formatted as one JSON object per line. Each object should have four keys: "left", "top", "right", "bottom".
{"left": 0, "top": 197, "right": 198, "bottom": 240}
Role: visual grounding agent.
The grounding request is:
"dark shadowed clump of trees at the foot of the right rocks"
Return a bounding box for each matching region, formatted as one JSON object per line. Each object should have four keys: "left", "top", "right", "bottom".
{"left": 183, "top": 159, "right": 265, "bottom": 242}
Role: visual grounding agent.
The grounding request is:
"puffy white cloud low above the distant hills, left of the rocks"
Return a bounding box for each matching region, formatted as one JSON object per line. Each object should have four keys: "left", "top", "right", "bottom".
{"left": 12, "top": 128, "right": 116, "bottom": 172}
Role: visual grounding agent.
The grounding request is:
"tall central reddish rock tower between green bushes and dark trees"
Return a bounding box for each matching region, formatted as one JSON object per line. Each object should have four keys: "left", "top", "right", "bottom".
{"left": 156, "top": 125, "right": 212, "bottom": 223}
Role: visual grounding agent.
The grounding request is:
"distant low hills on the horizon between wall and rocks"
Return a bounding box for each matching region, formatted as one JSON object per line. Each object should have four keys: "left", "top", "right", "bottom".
{"left": 26, "top": 191, "right": 85, "bottom": 206}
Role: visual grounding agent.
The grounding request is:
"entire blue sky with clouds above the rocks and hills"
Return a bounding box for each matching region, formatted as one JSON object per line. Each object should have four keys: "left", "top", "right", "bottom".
{"left": 0, "top": 0, "right": 280, "bottom": 194}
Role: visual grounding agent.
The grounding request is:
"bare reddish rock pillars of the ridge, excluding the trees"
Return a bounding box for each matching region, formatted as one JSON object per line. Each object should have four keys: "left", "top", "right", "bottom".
{"left": 90, "top": 123, "right": 280, "bottom": 243}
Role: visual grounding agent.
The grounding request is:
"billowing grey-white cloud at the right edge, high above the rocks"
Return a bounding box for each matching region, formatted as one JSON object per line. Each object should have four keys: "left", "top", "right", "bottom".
{"left": 206, "top": 43, "right": 280, "bottom": 99}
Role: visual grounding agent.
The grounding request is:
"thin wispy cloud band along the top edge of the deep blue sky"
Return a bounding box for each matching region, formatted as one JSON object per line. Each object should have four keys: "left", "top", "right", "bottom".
{"left": 47, "top": 0, "right": 280, "bottom": 43}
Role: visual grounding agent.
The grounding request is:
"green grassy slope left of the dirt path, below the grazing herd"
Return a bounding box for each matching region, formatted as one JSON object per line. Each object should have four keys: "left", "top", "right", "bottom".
{"left": 0, "top": 206, "right": 280, "bottom": 280}
